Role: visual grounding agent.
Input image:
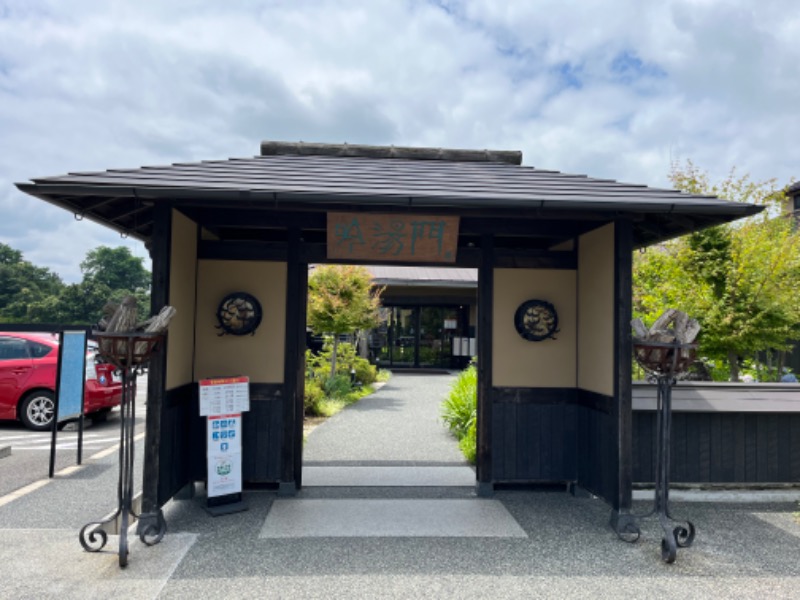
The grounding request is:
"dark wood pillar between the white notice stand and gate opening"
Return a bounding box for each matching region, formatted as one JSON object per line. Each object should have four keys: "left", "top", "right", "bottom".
{"left": 279, "top": 227, "right": 308, "bottom": 495}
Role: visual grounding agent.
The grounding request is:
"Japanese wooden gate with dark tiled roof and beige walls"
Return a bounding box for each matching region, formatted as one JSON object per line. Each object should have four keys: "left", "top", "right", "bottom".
{"left": 18, "top": 142, "right": 757, "bottom": 520}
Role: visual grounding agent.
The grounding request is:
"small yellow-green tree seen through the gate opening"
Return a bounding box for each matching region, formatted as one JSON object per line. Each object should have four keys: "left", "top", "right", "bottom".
{"left": 308, "top": 265, "right": 383, "bottom": 378}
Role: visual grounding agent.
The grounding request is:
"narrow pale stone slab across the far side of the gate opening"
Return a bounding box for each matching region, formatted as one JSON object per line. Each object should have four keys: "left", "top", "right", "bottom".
{"left": 303, "top": 467, "right": 475, "bottom": 487}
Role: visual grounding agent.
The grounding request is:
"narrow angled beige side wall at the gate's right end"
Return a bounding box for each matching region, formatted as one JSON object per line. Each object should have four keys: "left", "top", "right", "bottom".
{"left": 578, "top": 223, "right": 614, "bottom": 396}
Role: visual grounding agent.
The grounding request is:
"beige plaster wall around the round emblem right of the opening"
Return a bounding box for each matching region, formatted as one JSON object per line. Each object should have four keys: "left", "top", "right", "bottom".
{"left": 494, "top": 269, "right": 577, "bottom": 387}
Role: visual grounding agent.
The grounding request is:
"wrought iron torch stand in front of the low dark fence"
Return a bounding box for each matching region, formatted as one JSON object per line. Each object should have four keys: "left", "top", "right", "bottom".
{"left": 617, "top": 340, "right": 696, "bottom": 563}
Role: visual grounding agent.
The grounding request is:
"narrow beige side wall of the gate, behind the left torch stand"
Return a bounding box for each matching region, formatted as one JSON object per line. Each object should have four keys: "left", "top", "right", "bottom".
{"left": 166, "top": 210, "right": 197, "bottom": 390}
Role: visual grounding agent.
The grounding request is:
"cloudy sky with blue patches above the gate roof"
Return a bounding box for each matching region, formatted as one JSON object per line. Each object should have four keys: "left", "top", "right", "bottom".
{"left": 0, "top": 0, "right": 800, "bottom": 282}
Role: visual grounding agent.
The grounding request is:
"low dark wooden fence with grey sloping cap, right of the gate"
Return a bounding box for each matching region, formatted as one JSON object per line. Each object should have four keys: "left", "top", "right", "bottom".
{"left": 633, "top": 383, "right": 800, "bottom": 484}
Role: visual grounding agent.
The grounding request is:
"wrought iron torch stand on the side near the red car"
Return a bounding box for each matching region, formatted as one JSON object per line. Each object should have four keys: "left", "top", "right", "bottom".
{"left": 78, "top": 332, "right": 167, "bottom": 567}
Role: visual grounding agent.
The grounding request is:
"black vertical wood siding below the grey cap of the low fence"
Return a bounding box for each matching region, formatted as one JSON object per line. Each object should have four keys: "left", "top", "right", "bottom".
{"left": 633, "top": 411, "right": 800, "bottom": 483}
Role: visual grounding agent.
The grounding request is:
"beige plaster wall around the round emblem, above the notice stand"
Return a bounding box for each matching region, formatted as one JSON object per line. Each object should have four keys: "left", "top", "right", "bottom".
{"left": 194, "top": 260, "right": 287, "bottom": 383}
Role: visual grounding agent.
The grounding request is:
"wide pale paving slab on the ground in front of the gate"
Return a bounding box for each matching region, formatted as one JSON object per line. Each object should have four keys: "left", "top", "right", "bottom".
{"left": 259, "top": 498, "right": 528, "bottom": 538}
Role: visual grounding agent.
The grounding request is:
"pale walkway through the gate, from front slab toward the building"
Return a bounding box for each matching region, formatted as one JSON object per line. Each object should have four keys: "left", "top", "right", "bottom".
{"left": 292, "top": 373, "right": 494, "bottom": 538}
